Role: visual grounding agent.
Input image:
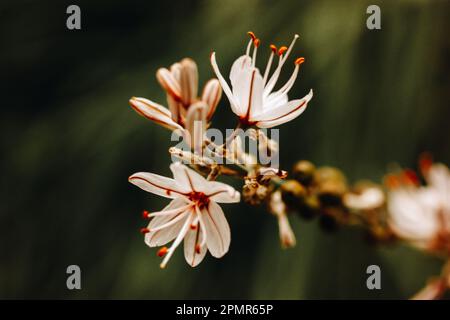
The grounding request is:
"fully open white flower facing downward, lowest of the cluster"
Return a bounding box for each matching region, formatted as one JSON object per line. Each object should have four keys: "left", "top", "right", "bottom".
{"left": 129, "top": 162, "right": 240, "bottom": 268}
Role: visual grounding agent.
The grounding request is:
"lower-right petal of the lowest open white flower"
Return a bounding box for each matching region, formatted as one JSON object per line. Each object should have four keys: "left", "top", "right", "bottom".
{"left": 202, "top": 201, "right": 231, "bottom": 258}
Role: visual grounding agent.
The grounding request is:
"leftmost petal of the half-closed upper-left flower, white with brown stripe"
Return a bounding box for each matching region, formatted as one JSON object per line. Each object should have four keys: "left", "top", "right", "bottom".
{"left": 129, "top": 98, "right": 183, "bottom": 130}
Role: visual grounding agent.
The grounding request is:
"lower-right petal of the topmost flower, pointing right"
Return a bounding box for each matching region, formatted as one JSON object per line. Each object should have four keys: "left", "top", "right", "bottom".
{"left": 255, "top": 90, "right": 313, "bottom": 128}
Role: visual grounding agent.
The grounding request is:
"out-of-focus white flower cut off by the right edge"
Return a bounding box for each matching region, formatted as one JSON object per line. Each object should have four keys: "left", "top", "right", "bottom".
{"left": 388, "top": 164, "right": 450, "bottom": 254}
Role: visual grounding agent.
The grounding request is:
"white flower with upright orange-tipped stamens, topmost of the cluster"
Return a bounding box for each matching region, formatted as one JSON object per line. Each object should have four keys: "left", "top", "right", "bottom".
{"left": 211, "top": 32, "right": 313, "bottom": 128}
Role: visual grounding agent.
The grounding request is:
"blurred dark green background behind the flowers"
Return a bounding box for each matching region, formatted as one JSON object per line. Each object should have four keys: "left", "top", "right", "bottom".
{"left": 0, "top": 0, "right": 450, "bottom": 299}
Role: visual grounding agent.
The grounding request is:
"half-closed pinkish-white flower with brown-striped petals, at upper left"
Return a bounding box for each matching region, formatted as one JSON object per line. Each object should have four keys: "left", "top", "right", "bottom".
{"left": 129, "top": 58, "right": 222, "bottom": 130}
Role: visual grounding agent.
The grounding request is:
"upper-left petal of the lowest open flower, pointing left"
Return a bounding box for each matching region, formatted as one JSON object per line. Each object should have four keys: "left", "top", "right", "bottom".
{"left": 128, "top": 172, "right": 188, "bottom": 199}
